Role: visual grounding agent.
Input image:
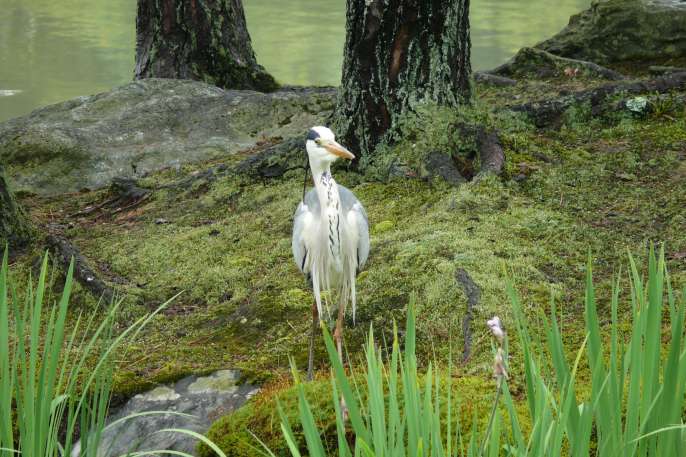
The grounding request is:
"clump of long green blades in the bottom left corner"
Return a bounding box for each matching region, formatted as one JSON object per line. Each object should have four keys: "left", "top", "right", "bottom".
{"left": 0, "top": 249, "right": 230, "bottom": 457}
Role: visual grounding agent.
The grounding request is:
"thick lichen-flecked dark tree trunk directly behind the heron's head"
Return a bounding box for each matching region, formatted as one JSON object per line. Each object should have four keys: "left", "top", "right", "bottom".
{"left": 335, "top": 0, "right": 471, "bottom": 154}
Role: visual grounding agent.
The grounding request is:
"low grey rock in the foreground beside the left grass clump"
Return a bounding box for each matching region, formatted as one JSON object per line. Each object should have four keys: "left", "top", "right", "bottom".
{"left": 71, "top": 370, "right": 258, "bottom": 457}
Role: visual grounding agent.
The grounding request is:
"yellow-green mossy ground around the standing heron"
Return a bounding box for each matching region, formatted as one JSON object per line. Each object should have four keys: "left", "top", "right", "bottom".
{"left": 15, "top": 73, "right": 686, "bottom": 450}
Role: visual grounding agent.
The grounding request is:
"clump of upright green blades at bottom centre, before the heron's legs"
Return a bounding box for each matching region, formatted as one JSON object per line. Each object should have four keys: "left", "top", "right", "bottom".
{"left": 272, "top": 302, "right": 486, "bottom": 457}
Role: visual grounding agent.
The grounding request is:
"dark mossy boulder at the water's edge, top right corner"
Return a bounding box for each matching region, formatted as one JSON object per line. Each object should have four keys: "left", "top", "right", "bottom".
{"left": 536, "top": 0, "right": 686, "bottom": 64}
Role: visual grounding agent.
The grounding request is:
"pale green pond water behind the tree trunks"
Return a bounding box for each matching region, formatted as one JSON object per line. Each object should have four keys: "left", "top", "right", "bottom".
{"left": 0, "top": 0, "right": 590, "bottom": 121}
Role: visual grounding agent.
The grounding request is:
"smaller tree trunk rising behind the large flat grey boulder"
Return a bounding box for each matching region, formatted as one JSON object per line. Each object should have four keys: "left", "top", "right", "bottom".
{"left": 135, "top": 0, "right": 278, "bottom": 92}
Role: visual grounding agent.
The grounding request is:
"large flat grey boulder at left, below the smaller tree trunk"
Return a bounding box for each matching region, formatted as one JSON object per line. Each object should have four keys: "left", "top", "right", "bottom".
{"left": 0, "top": 79, "right": 336, "bottom": 195}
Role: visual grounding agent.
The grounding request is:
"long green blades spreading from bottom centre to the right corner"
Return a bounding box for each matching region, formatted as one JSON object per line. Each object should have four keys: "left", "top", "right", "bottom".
{"left": 276, "top": 249, "right": 686, "bottom": 457}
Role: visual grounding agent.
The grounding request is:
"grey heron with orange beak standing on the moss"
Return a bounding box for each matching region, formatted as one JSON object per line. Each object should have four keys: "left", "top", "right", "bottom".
{"left": 292, "top": 126, "right": 369, "bottom": 379}
